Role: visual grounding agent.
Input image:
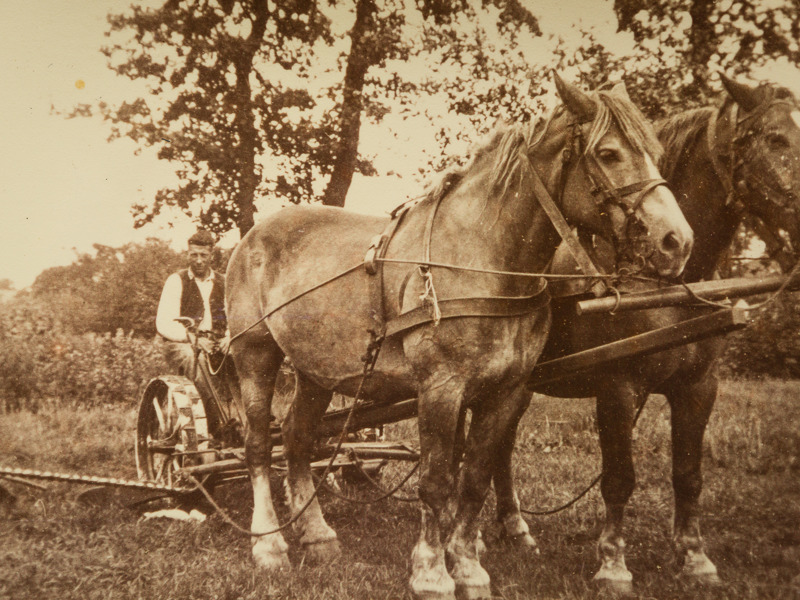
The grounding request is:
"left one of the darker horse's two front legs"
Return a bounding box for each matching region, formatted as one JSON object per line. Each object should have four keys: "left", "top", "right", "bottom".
{"left": 594, "top": 381, "right": 644, "bottom": 593}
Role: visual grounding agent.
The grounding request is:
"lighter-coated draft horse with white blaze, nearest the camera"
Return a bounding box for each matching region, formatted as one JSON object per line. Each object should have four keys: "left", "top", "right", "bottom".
{"left": 226, "top": 75, "right": 692, "bottom": 598}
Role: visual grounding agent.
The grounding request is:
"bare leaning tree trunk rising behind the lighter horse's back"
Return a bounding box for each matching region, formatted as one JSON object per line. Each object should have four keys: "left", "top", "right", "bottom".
{"left": 322, "top": 0, "right": 377, "bottom": 206}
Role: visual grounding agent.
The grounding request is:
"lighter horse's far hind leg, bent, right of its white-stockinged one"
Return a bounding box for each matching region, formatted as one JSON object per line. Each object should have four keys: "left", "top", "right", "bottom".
{"left": 283, "top": 372, "right": 340, "bottom": 562}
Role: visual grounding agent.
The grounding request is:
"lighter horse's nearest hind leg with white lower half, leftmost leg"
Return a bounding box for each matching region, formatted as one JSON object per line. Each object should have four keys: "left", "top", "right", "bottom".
{"left": 232, "top": 334, "right": 290, "bottom": 570}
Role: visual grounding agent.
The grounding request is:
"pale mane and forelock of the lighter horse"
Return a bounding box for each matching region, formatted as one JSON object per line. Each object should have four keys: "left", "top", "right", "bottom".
{"left": 423, "top": 91, "right": 663, "bottom": 202}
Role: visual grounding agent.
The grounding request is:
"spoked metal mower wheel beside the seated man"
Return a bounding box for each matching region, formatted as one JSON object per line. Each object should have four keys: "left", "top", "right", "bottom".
{"left": 136, "top": 376, "right": 214, "bottom": 486}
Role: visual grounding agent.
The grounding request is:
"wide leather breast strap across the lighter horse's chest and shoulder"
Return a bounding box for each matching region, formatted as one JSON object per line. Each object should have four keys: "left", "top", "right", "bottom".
{"left": 386, "top": 280, "right": 550, "bottom": 337}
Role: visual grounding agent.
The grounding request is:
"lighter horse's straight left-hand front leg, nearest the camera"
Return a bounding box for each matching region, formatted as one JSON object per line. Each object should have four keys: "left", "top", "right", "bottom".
{"left": 410, "top": 372, "right": 464, "bottom": 600}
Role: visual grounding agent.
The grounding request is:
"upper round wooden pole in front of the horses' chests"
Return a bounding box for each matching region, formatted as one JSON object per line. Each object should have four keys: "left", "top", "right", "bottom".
{"left": 576, "top": 276, "right": 800, "bottom": 315}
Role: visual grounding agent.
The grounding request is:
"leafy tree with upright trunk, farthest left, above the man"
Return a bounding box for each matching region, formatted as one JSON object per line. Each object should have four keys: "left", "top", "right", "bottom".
{"left": 86, "top": 0, "right": 333, "bottom": 234}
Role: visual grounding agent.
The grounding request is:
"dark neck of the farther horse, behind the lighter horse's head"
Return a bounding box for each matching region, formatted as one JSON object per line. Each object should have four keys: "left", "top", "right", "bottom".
{"left": 670, "top": 129, "right": 741, "bottom": 281}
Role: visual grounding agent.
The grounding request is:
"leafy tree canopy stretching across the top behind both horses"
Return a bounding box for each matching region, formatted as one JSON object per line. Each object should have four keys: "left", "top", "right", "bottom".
{"left": 75, "top": 0, "right": 800, "bottom": 240}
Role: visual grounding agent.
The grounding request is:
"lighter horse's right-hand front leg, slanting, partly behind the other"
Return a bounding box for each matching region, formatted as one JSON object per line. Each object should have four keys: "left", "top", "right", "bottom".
{"left": 447, "top": 386, "right": 530, "bottom": 599}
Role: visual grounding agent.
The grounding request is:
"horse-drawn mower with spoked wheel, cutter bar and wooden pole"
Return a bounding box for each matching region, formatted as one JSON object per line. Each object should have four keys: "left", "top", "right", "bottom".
{"left": 0, "top": 276, "right": 788, "bottom": 504}
